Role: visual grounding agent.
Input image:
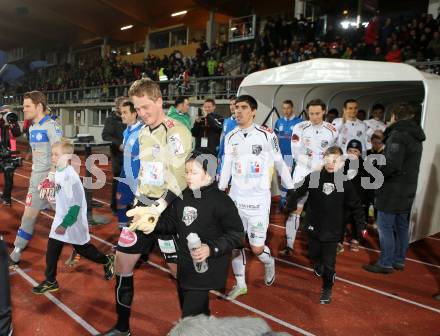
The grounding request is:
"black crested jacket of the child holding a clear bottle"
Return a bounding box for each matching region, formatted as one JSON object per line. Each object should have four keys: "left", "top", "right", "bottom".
{"left": 155, "top": 183, "right": 244, "bottom": 290}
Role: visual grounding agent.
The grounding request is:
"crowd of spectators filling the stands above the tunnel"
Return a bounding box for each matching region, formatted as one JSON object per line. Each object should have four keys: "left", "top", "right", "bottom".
{"left": 7, "top": 10, "right": 440, "bottom": 92}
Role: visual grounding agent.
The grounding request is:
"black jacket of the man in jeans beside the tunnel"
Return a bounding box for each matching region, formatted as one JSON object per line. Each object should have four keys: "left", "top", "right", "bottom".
{"left": 375, "top": 119, "right": 426, "bottom": 214}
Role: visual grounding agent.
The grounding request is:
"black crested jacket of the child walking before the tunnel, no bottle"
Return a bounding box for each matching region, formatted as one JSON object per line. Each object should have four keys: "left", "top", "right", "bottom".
{"left": 288, "top": 168, "right": 365, "bottom": 242}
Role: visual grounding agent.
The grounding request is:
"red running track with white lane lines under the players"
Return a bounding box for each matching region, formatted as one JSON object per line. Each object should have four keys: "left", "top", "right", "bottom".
{"left": 0, "top": 150, "right": 440, "bottom": 335}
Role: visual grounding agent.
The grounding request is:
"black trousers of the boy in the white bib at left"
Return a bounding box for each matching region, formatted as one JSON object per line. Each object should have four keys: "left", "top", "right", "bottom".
{"left": 45, "top": 238, "right": 108, "bottom": 282}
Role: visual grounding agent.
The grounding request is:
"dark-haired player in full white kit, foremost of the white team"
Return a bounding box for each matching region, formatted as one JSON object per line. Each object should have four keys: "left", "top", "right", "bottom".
{"left": 219, "top": 95, "right": 293, "bottom": 299}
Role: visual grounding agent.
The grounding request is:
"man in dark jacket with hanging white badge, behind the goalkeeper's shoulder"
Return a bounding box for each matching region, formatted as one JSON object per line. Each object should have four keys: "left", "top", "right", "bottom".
{"left": 191, "top": 99, "right": 223, "bottom": 153}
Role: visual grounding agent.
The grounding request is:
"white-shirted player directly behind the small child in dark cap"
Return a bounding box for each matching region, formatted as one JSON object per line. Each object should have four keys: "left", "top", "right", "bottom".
{"left": 332, "top": 99, "right": 367, "bottom": 157}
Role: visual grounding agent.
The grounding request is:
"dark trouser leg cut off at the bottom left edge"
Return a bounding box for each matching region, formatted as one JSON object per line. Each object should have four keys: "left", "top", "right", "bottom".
{"left": 0, "top": 237, "right": 12, "bottom": 336}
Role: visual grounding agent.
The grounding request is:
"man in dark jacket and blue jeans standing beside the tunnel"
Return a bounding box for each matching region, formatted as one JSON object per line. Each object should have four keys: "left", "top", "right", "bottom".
{"left": 363, "top": 104, "right": 426, "bottom": 274}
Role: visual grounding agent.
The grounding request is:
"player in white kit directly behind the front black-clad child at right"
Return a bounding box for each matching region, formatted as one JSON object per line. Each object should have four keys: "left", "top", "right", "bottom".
{"left": 279, "top": 99, "right": 338, "bottom": 257}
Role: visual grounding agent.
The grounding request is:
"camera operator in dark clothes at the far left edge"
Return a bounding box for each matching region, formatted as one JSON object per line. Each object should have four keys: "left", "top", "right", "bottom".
{"left": 0, "top": 107, "right": 21, "bottom": 206}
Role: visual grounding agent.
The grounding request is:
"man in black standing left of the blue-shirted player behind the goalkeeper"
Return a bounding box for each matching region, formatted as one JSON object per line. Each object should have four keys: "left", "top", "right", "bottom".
{"left": 102, "top": 97, "right": 128, "bottom": 213}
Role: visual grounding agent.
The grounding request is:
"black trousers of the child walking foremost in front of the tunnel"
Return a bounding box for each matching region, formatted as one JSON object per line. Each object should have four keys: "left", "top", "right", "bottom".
{"left": 309, "top": 236, "right": 338, "bottom": 289}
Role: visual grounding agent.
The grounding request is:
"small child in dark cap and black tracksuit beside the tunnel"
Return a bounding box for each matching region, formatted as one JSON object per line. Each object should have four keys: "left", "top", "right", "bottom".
{"left": 338, "top": 139, "right": 374, "bottom": 252}
